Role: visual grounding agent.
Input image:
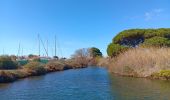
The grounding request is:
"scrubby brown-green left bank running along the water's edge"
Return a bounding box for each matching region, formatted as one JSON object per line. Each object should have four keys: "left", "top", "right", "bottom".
{"left": 0, "top": 60, "right": 86, "bottom": 83}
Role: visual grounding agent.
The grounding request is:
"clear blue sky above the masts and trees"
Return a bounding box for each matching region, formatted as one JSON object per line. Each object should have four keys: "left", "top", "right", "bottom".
{"left": 0, "top": 0, "right": 170, "bottom": 57}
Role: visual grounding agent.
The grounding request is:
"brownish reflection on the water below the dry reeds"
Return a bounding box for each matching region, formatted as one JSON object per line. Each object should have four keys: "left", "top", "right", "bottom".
{"left": 110, "top": 75, "right": 170, "bottom": 100}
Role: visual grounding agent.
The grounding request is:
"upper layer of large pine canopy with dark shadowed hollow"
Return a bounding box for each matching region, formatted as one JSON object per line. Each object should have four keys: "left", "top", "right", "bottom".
{"left": 113, "top": 28, "right": 170, "bottom": 46}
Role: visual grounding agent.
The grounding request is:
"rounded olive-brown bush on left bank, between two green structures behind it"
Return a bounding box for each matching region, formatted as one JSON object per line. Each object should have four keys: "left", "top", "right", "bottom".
{"left": 24, "top": 61, "right": 46, "bottom": 75}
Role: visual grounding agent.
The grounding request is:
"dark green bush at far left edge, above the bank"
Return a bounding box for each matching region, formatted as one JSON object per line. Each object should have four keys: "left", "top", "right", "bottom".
{"left": 0, "top": 56, "right": 18, "bottom": 69}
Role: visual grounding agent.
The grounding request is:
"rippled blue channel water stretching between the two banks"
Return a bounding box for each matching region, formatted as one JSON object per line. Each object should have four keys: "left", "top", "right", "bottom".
{"left": 0, "top": 67, "right": 170, "bottom": 100}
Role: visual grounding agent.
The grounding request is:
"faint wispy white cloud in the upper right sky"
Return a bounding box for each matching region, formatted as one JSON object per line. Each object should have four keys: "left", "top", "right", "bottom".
{"left": 144, "top": 9, "right": 163, "bottom": 21}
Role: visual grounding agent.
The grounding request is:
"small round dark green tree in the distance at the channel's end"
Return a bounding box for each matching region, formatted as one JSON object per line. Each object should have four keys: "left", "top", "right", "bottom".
{"left": 89, "top": 47, "right": 102, "bottom": 58}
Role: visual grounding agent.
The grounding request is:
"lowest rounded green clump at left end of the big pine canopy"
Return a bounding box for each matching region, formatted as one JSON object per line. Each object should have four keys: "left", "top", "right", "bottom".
{"left": 107, "top": 43, "right": 128, "bottom": 57}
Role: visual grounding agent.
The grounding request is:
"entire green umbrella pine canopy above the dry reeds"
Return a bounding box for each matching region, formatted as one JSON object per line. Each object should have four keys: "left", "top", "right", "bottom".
{"left": 107, "top": 28, "right": 170, "bottom": 57}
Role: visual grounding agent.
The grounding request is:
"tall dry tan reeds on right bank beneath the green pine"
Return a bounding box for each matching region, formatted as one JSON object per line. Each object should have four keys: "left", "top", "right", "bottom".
{"left": 109, "top": 48, "right": 170, "bottom": 77}
